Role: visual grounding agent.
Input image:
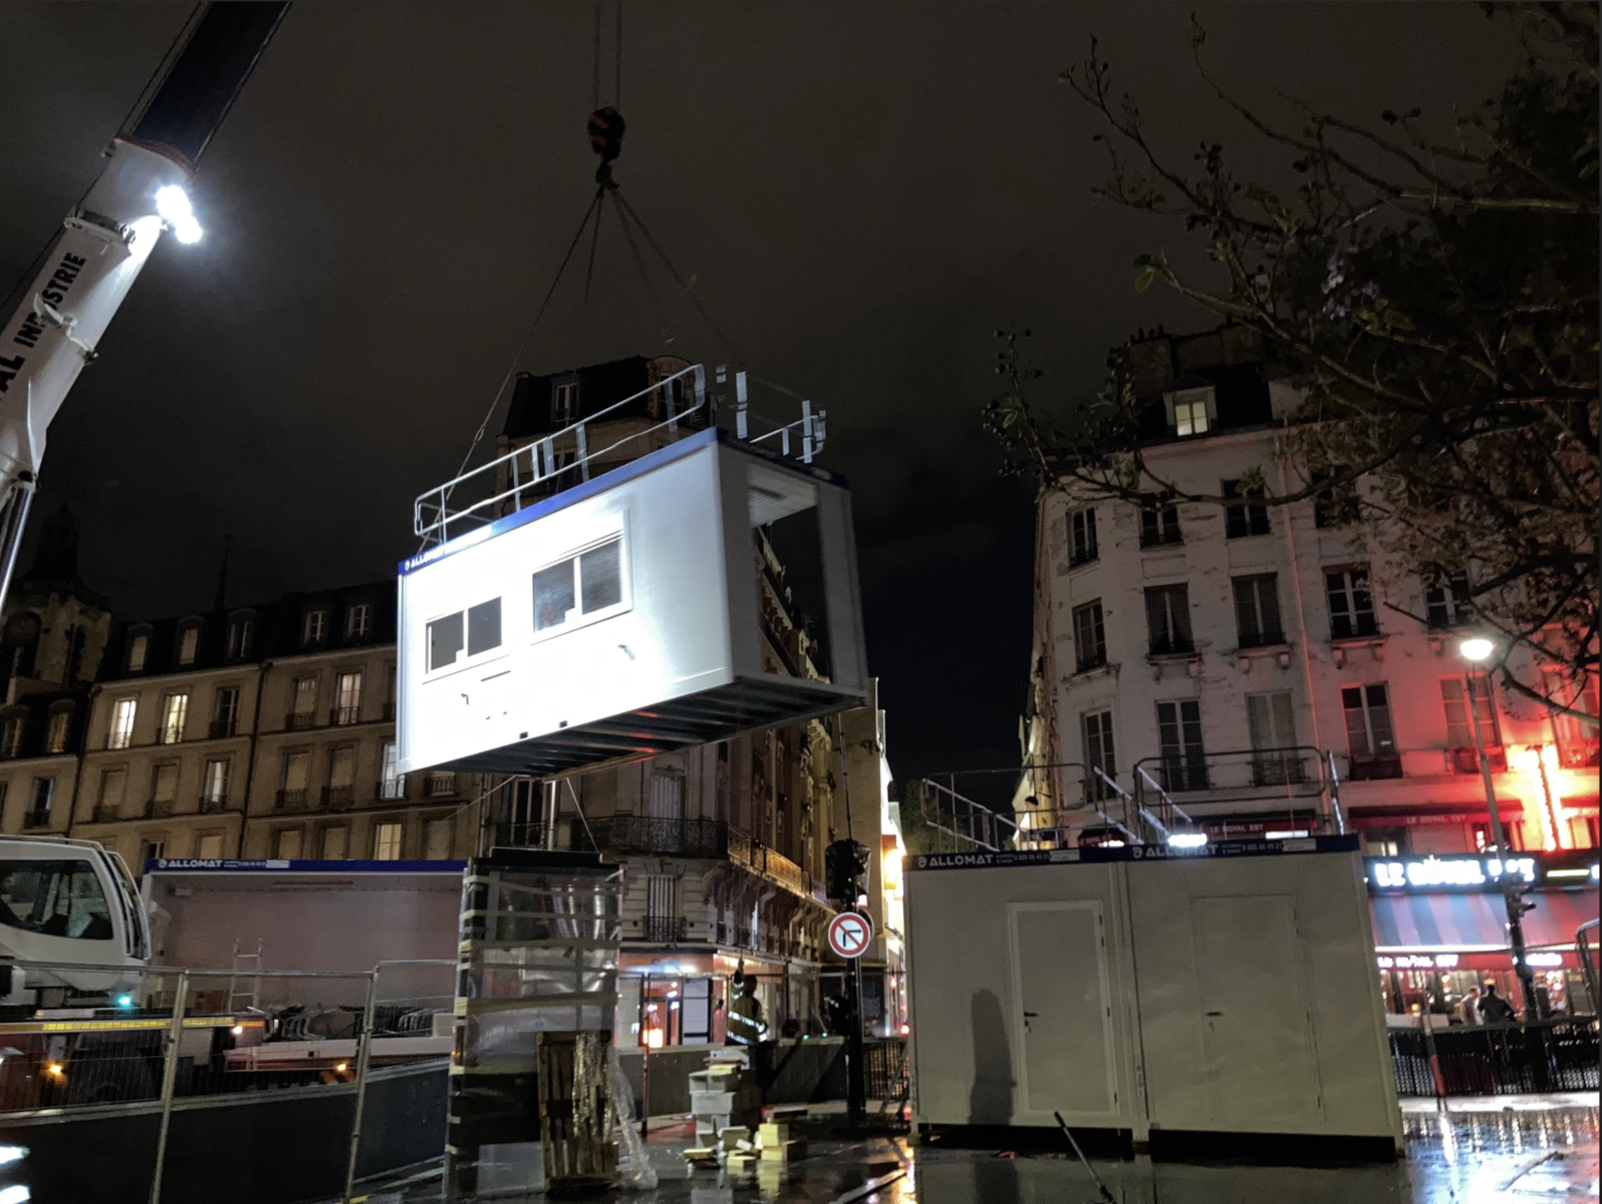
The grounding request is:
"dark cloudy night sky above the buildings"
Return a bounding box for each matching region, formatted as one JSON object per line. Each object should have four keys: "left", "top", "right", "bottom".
{"left": 0, "top": 2, "right": 1512, "bottom": 778}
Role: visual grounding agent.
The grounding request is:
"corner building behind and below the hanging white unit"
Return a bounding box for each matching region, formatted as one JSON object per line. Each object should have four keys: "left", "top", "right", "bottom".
{"left": 484, "top": 357, "right": 902, "bottom": 1045}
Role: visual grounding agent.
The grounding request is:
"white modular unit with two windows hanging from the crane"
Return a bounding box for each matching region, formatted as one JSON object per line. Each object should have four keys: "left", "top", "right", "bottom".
{"left": 397, "top": 429, "right": 868, "bottom": 777}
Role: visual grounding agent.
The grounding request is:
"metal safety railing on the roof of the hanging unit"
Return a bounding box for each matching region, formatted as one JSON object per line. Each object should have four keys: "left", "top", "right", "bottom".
{"left": 412, "top": 363, "right": 827, "bottom": 549}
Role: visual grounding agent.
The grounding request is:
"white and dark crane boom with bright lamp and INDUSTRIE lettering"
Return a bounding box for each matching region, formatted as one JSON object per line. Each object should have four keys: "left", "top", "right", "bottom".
{"left": 0, "top": 3, "right": 288, "bottom": 605}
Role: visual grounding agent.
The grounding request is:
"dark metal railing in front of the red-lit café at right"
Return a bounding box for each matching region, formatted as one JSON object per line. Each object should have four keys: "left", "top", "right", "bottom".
{"left": 1391, "top": 1017, "right": 1599, "bottom": 1097}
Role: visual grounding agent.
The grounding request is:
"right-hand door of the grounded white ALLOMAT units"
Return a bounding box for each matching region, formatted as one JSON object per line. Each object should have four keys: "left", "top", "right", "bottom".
{"left": 1190, "top": 895, "right": 1323, "bottom": 1129}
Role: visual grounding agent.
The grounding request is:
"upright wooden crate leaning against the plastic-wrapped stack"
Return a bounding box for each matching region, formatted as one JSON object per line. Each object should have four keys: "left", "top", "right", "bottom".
{"left": 535, "top": 1033, "right": 618, "bottom": 1191}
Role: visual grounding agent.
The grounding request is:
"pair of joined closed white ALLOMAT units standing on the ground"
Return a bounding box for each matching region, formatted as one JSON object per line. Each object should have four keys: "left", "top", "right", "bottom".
{"left": 907, "top": 836, "right": 1402, "bottom": 1158}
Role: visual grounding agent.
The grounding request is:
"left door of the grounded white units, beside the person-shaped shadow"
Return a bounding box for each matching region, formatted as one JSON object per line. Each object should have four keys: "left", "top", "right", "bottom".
{"left": 1008, "top": 901, "right": 1117, "bottom": 1119}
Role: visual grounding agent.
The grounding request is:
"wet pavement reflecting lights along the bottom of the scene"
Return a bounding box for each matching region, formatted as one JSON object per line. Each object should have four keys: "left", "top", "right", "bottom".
{"left": 354, "top": 1097, "right": 1597, "bottom": 1204}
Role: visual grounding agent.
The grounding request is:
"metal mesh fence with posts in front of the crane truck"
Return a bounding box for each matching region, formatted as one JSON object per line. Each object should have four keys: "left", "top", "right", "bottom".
{"left": 0, "top": 961, "right": 457, "bottom": 1204}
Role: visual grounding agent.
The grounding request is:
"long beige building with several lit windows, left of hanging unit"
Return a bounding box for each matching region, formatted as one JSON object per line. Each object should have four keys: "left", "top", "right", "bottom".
{"left": 0, "top": 581, "right": 481, "bottom": 873}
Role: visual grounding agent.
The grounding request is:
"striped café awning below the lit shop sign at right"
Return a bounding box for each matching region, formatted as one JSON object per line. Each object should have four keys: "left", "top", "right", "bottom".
{"left": 1368, "top": 890, "right": 1597, "bottom": 953}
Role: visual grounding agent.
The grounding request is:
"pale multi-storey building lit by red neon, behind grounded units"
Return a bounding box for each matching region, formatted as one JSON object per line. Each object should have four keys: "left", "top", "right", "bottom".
{"left": 1019, "top": 327, "right": 1597, "bottom": 855}
